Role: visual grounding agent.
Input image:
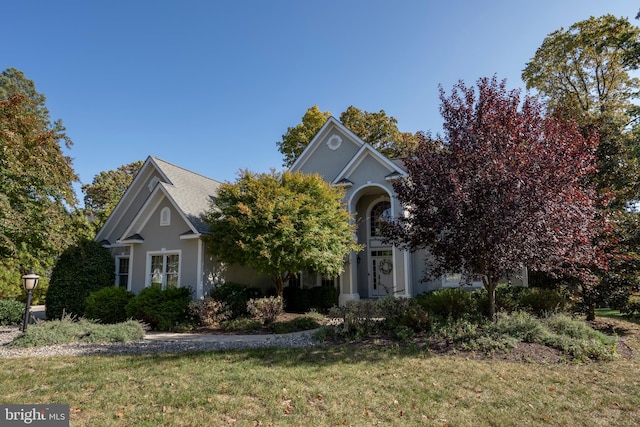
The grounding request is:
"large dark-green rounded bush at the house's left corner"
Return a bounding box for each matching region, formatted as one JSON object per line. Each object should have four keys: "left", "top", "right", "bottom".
{"left": 46, "top": 240, "right": 115, "bottom": 319}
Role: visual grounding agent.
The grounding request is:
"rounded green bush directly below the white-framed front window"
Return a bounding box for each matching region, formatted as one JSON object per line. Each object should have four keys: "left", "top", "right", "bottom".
{"left": 126, "top": 286, "right": 191, "bottom": 331}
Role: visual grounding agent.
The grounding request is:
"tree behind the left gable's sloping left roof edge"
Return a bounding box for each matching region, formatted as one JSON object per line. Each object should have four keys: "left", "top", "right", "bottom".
{"left": 82, "top": 160, "right": 144, "bottom": 230}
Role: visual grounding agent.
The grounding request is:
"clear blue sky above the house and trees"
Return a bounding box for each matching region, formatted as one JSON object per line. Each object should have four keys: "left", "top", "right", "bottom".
{"left": 0, "top": 0, "right": 640, "bottom": 204}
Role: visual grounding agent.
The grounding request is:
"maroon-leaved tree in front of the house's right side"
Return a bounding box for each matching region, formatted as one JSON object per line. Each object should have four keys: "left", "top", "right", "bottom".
{"left": 387, "top": 76, "right": 606, "bottom": 316}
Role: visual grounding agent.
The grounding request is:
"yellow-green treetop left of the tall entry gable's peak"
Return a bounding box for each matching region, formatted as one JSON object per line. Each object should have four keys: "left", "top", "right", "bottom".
{"left": 277, "top": 105, "right": 331, "bottom": 167}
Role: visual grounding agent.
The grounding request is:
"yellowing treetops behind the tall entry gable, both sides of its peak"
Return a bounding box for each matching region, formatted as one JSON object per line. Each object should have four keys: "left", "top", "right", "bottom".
{"left": 277, "top": 105, "right": 418, "bottom": 167}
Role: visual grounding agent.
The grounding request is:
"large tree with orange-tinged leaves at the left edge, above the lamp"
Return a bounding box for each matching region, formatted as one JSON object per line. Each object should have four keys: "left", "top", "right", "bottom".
{"left": 0, "top": 68, "right": 87, "bottom": 269}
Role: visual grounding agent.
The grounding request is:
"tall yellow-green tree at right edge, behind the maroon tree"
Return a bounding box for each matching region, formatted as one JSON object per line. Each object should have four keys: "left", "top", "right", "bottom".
{"left": 522, "top": 15, "right": 640, "bottom": 317}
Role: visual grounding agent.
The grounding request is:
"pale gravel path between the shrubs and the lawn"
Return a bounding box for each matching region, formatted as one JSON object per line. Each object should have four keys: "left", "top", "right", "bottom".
{"left": 0, "top": 327, "right": 319, "bottom": 358}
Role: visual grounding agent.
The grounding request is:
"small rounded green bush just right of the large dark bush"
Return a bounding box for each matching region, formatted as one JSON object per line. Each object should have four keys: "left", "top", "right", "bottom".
{"left": 84, "top": 286, "right": 134, "bottom": 323}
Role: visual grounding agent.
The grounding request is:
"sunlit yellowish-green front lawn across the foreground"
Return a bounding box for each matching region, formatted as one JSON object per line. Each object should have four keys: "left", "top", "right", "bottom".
{"left": 0, "top": 319, "right": 640, "bottom": 426}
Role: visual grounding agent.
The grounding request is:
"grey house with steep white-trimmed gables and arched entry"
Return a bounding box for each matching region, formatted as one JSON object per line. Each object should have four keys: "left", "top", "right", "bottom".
{"left": 96, "top": 117, "right": 526, "bottom": 305}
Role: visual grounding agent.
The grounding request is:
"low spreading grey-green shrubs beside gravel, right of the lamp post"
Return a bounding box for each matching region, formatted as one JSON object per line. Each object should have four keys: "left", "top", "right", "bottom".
{"left": 11, "top": 316, "right": 145, "bottom": 347}
